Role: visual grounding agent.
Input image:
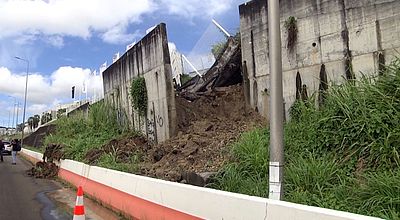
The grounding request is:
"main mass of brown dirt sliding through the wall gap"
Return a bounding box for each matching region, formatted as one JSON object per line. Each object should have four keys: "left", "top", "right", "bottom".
{"left": 141, "top": 85, "right": 263, "bottom": 181}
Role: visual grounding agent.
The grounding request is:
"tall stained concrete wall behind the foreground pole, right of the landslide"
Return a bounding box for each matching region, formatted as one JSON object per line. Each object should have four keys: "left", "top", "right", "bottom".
{"left": 239, "top": 0, "right": 400, "bottom": 117}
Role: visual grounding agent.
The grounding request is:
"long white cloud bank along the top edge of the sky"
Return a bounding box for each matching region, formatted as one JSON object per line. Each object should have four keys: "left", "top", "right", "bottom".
{"left": 0, "top": 0, "right": 237, "bottom": 47}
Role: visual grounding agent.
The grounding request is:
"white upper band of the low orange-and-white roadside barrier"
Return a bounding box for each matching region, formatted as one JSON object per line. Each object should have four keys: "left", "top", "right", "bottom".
{"left": 24, "top": 150, "right": 378, "bottom": 220}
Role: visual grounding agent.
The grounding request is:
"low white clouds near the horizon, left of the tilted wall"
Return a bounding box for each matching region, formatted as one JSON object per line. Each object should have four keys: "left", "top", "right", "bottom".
{"left": 0, "top": 66, "right": 103, "bottom": 117}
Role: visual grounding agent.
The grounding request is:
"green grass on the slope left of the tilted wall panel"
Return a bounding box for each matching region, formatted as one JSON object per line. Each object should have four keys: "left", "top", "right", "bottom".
{"left": 44, "top": 102, "right": 139, "bottom": 173}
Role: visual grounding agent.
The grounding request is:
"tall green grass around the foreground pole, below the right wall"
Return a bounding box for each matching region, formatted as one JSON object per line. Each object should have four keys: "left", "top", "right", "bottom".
{"left": 214, "top": 59, "right": 400, "bottom": 219}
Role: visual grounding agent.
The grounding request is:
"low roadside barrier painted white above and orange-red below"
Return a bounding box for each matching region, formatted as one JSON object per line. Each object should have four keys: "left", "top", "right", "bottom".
{"left": 21, "top": 149, "right": 377, "bottom": 220}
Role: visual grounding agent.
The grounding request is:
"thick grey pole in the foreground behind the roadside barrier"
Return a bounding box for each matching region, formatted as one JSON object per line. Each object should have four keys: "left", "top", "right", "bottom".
{"left": 268, "top": 0, "right": 284, "bottom": 200}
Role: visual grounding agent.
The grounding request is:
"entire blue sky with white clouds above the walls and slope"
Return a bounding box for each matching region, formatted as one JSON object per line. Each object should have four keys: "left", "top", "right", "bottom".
{"left": 0, "top": 0, "right": 246, "bottom": 127}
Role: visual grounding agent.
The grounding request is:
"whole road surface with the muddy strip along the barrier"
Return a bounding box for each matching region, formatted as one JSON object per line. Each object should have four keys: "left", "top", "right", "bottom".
{"left": 0, "top": 156, "right": 120, "bottom": 220}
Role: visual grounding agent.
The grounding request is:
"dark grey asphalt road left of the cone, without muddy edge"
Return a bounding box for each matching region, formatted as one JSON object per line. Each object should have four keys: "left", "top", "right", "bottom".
{"left": 0, "top": 153, "right": 70, "bottom": 220}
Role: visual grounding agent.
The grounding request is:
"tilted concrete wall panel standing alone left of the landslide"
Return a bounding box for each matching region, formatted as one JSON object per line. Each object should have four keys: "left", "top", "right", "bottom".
{"left": 103, "top": 23, "right": 176, "bottom": 142}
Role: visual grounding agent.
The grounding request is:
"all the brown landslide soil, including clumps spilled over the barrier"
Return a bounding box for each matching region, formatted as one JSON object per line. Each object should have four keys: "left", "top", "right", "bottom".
{"left": 37, "top": 85, "right": 265, "bottom": 185}
